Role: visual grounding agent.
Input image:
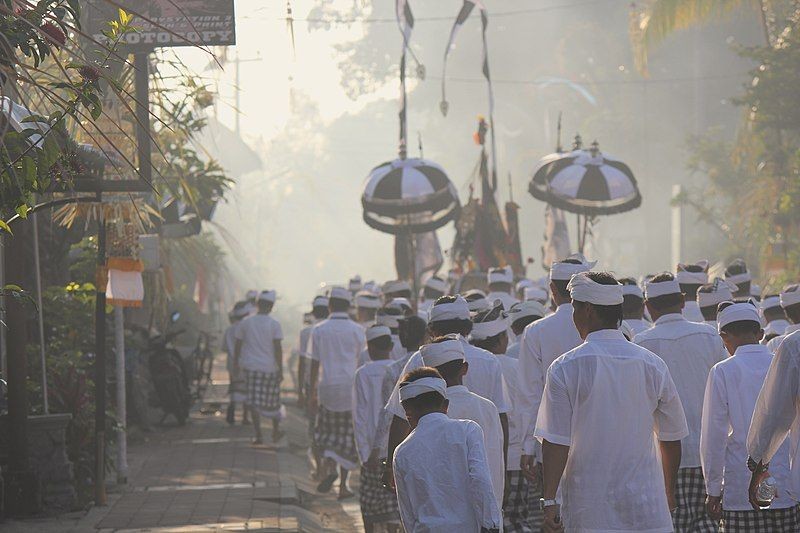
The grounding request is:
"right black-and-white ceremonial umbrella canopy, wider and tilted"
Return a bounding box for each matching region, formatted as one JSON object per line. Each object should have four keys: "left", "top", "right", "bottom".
{"left": 528, "top": 144, "right": 642, "bottom": 216}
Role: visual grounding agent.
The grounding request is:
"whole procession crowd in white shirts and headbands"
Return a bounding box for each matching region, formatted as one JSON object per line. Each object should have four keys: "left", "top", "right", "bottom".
{"left": 225, "top": 254, "right": 800, "bottom": 533}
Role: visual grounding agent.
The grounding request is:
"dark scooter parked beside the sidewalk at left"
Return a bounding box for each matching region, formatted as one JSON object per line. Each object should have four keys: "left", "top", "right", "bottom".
{"left": 148, "top": 311, "right": 192, "bottom": 426}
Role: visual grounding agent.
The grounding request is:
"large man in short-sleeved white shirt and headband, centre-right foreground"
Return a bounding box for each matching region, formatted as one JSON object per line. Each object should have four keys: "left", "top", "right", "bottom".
{"left": 535, "top": 272, "right": 688, "bottom": 533}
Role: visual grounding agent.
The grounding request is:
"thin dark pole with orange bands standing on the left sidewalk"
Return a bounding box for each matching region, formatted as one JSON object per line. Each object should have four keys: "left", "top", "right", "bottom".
{"left": 94, "top": 197, "right": 106, "bottom": 505}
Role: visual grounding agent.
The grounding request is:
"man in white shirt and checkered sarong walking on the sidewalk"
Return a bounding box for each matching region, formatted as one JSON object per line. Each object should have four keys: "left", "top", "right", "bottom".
{"left": 234, "top": 291, "right": 285, "bottom": 445}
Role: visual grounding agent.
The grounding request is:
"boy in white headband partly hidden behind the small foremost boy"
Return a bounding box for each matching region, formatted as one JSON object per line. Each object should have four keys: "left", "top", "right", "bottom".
{"left": 420, "top": 335, "right": 506, "bottom": 507}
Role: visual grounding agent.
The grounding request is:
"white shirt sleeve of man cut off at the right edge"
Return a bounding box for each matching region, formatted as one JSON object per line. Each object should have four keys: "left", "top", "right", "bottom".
{"left": 747, "top": 332, "right": 800, "bottom": 501}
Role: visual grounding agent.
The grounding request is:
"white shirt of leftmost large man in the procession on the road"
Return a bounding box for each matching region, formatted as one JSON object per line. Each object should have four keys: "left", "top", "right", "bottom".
{"left": 311, "top": 313, "right": 366, "bottom": 412}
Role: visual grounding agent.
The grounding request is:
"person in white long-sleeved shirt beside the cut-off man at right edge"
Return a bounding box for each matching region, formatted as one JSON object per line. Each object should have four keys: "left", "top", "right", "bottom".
{"left": 700, "top": 302, "right": 800, "bottom": 533}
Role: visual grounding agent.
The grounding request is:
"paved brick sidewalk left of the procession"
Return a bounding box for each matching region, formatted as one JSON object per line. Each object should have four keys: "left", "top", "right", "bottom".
{"left": 0, "top": 357, "right": 363, "bottom": 532}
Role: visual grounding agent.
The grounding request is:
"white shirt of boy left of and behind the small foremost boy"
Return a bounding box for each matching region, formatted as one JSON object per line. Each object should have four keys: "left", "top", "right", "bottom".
{"left": 352, "top": 359, "right": 394, "bottom": 464}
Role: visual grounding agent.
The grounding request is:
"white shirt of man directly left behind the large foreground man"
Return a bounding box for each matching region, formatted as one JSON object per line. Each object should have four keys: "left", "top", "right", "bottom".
{"left": 519, "top": 303, "right": 583, "bottom": 455}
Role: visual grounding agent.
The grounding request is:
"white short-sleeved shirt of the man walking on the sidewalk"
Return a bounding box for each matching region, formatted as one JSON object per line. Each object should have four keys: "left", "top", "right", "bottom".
{"left": 236, "top": 313, "right": 283, "bottom": 374}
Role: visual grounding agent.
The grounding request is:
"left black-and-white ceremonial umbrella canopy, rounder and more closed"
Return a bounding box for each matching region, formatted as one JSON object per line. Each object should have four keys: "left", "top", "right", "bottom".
{"left": 361, "top": 158, "right": 461, "bottom": 235}
